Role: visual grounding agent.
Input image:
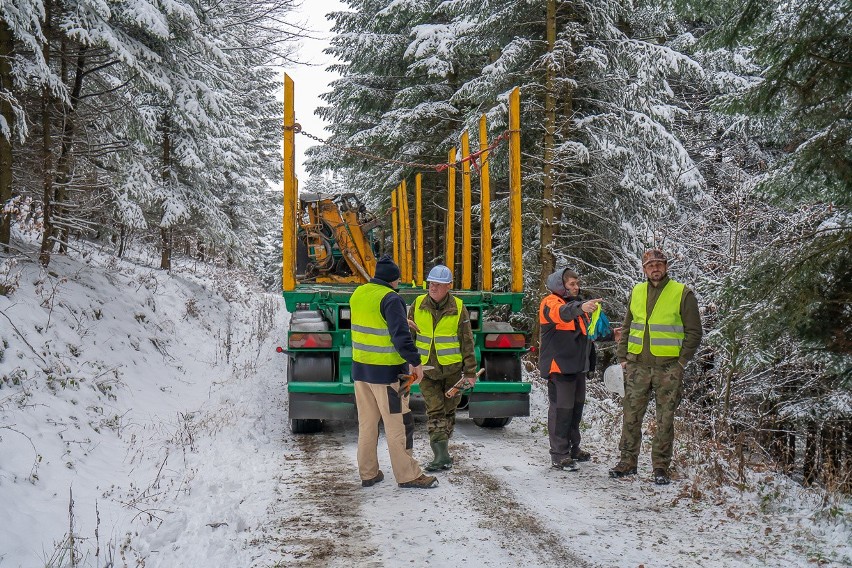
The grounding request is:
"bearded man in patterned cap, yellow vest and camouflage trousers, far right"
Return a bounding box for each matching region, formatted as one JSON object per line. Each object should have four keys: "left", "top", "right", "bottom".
{"left": 609, "top": 249, "right": 702, "bottom": 485}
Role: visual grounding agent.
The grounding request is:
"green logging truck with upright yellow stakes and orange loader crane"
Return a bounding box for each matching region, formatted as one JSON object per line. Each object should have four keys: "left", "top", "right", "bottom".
{"left": 282, "top": 75, "right": 530, "bottom": 433}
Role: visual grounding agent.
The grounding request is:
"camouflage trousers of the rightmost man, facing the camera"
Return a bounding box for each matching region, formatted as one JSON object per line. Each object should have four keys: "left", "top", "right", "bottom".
{"left": 618, "top": 361, "right": 683, "bottom": 469}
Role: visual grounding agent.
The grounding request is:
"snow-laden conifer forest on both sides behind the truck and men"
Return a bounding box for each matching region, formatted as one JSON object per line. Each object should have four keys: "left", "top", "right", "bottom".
{"left": 0, "top": 0, "right": 852, "bottom": 493}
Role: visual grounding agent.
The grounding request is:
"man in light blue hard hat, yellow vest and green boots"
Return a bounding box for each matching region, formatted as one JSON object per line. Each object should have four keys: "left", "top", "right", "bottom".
{"left": 408, "top": 264, "right": 476, "bottom": 471}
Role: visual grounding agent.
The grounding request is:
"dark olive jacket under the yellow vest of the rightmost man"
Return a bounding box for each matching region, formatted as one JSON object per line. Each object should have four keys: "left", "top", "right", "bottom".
{"left": 616, "top": 276, "right": 703, "bottom": 367}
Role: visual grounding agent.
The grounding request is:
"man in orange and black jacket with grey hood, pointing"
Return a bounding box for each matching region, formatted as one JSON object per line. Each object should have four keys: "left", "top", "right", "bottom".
{"left": 538, "top": 268, "right": 603, "bottom": 471}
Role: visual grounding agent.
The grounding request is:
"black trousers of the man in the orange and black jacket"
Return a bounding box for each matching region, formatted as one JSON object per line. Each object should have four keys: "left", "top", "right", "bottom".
{"left": 547, "top": 373, "right": 586, "bottom": 461}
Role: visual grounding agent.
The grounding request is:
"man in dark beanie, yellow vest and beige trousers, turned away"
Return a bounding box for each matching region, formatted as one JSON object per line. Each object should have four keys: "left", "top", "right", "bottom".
{"left": 349, "top": 256, "right": 438, "bottom": 489}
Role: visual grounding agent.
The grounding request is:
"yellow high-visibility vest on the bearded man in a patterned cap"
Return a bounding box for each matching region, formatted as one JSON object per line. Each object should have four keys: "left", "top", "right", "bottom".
{"left": 627, "top": 280, "right": 686, "bottom": 357}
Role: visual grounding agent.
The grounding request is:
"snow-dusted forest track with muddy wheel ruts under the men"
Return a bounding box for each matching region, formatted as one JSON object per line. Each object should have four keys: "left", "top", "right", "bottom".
{"left": 262, "top": 394, "right": 824, "bottom": 568}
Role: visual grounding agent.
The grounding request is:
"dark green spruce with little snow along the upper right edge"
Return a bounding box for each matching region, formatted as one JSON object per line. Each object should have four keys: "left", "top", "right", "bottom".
{"left": 708, "top": 0, "right": 852, "bottom": 380}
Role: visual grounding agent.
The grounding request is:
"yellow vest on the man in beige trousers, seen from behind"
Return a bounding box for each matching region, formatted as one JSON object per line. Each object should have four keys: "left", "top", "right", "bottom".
{"left": 349, "top": 283, "right": 405, "bottom": 366}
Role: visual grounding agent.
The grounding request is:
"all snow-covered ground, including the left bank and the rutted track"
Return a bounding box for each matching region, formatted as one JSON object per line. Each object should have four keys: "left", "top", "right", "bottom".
{"left": 0, "top": 245, "right": 852, "bottom": 568}
